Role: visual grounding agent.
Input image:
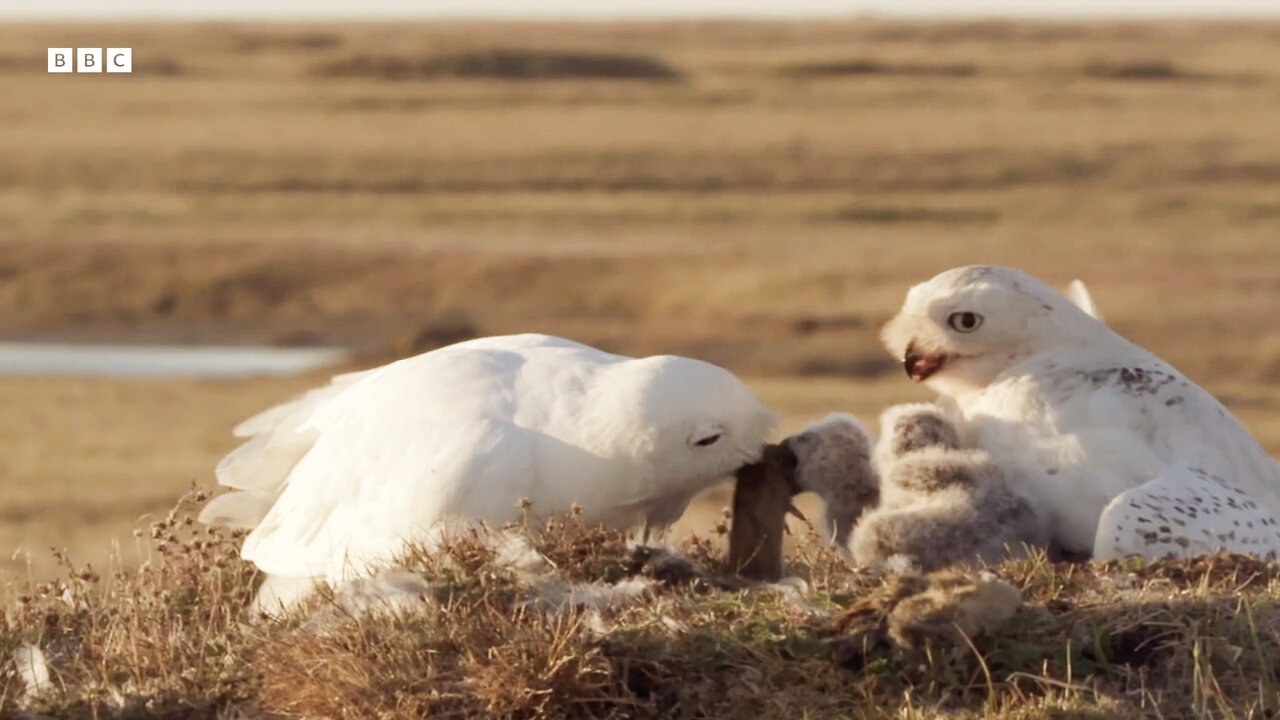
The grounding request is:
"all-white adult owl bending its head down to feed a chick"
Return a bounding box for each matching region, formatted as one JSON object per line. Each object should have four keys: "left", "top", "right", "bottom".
{"left": 201, "top": 334, "right": 774, "bottom": 607}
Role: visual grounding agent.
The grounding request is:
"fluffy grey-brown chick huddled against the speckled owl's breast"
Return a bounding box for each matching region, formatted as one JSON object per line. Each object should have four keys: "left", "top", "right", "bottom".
{"left": 850, "top": 404, "right": 1048, "bottom": 571}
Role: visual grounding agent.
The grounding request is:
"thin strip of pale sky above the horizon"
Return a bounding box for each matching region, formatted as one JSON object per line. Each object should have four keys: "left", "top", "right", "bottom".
{"left": 0, "top": 0, "right": 1280, "bottom": 20}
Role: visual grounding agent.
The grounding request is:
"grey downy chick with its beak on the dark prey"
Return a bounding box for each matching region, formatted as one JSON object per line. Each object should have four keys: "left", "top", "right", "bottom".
{"left": 782, "top": 413, "right": 879, "bottom": 547}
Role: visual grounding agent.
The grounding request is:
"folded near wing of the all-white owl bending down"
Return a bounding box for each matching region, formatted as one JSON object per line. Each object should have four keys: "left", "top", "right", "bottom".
{"left": 242, "top": 414, "right": 535, "bottom": 579}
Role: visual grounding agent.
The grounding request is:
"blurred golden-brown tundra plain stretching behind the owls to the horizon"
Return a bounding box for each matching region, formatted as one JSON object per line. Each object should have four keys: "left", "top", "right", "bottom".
{"left": 0, "top": 20, "right": 1280, "bottom": 575}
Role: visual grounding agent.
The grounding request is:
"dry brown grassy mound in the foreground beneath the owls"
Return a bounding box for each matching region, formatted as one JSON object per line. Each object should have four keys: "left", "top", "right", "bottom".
{"left": 0, "top": 497, "right": 1280, "bottom": 717}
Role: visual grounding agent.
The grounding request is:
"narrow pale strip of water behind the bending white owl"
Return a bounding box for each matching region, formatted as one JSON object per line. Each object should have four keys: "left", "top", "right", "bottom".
{"left": 0, "top": 342, "right": 349, "bottom": 378}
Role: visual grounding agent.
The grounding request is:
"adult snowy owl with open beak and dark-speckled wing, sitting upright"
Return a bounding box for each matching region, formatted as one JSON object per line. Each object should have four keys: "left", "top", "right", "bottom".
{"left": 882, "top": 265, "right": 1280, "bottom": 559}
